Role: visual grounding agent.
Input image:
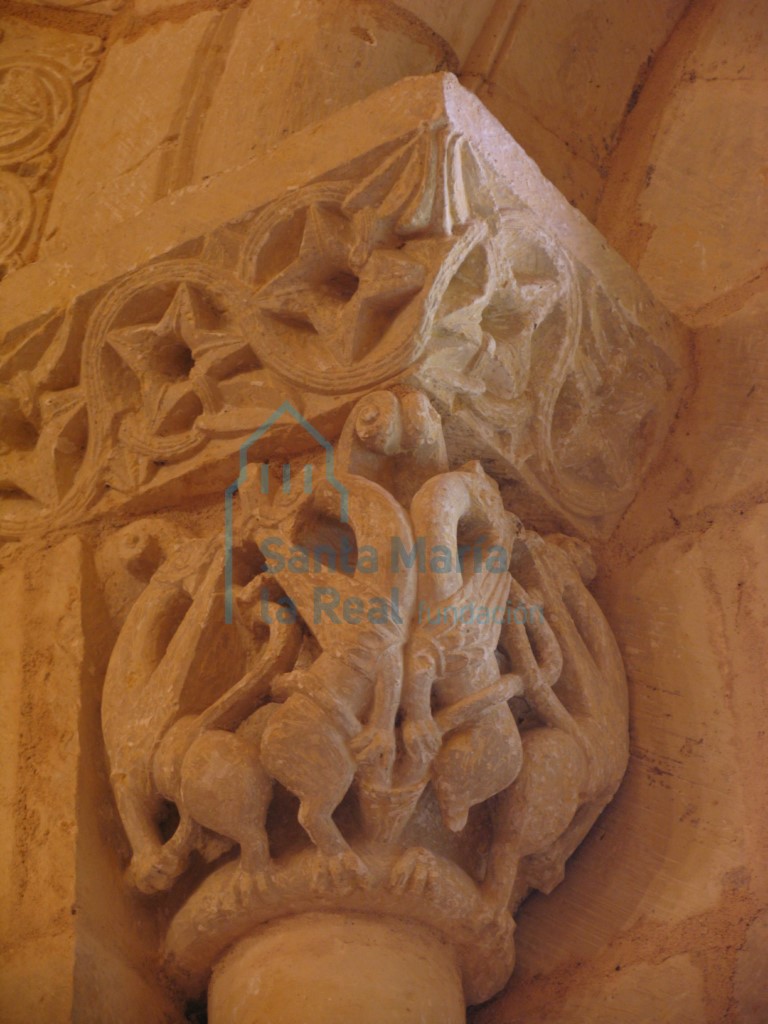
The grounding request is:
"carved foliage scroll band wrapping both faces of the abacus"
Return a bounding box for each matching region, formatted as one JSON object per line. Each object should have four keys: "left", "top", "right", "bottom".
{"left": 0, "top": 119, "right": 679, "bottom": 534}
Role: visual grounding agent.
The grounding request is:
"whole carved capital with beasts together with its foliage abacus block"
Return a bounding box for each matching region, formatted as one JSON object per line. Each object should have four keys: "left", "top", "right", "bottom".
{"left": 0, "top": 75, "right": 685, "bottom": 1024}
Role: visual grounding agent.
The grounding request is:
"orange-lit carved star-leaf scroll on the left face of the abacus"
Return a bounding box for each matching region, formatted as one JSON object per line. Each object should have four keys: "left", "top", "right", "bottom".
{"left": 0, "top": 131, "right": 482, "bottom": 534}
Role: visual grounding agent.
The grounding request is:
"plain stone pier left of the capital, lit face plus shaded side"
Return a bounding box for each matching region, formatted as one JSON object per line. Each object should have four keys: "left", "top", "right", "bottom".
{"left": 0, "top": 537, "right": 175, "bottom": 1024}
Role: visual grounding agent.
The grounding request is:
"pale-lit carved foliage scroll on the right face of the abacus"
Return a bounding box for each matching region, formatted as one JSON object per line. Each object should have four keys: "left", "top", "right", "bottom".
{"left": 420, "top": 208, "right": 679, "bottom": 526}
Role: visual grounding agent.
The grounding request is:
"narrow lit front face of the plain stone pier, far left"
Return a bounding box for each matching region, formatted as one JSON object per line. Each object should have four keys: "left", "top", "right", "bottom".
{"left": 0, "top": 538, "right": 83, "bottom": 1024}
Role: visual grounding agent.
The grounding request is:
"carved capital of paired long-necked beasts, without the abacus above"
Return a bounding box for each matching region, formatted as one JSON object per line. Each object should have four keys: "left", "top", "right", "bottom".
{"left": 102, "top": 388, "right": 627, "bottom": 1002}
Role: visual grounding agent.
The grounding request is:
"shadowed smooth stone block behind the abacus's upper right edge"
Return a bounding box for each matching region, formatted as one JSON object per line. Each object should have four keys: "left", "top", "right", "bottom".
{"left": 466, "top": 0, "right": 686, "bottom": 218}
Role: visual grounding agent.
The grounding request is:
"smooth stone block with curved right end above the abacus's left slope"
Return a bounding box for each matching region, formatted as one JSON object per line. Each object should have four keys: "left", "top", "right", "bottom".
{"left": 187, "top": 0, "right": 458, "bottom": 182}
